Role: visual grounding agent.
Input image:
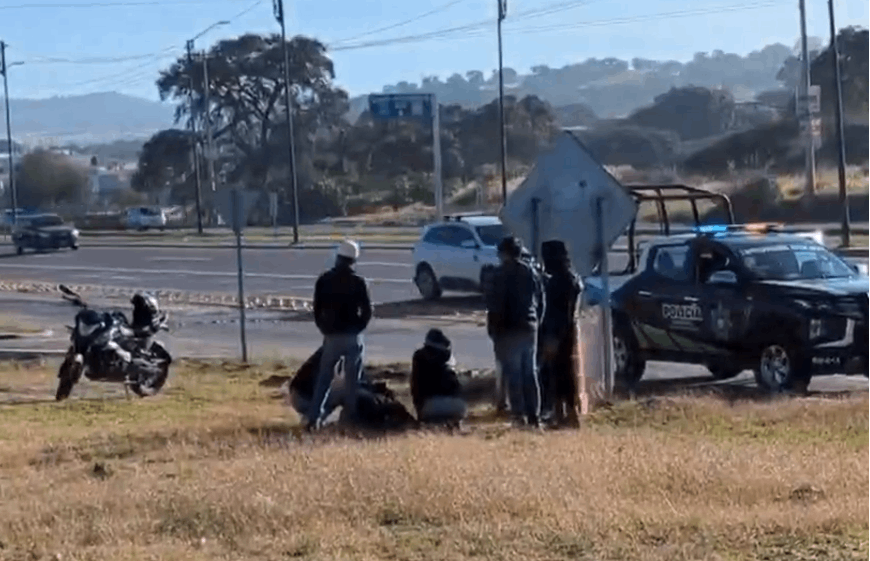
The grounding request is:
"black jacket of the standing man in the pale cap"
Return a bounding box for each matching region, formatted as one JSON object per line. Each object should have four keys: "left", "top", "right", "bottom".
{"left": 314, "top": 265, "right": 372, "bottom": 335}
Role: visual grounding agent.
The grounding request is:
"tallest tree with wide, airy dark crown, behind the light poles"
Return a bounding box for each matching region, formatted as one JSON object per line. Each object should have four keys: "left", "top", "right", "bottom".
{"left": 157, "top": 34, "right": 348, "bottom": 192}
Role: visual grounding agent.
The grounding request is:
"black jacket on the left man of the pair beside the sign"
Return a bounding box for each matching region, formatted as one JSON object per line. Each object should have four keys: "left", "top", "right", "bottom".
{"left": 486, "top": 260, "right": 545, "bottom": 337}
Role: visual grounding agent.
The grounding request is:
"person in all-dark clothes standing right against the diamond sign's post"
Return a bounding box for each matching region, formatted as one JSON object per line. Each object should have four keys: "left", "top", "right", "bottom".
{"left": 540, "top": 240, "right": 583, "bottom": 423}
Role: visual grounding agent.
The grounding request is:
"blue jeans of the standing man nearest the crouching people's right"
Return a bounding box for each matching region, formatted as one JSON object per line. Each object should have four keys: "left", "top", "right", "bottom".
{"left": 494, "top": 332, "right": 541, "bottom": 422}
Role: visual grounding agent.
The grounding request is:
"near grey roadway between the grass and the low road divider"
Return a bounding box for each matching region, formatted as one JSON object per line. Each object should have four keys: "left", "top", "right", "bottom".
{"left": 0, "top": 295, "right": 868, "bottom": 391}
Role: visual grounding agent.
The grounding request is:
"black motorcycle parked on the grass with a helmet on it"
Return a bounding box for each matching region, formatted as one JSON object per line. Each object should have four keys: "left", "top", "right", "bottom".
{"left": 55, "top": 285, "right": 172, "bottom": 401}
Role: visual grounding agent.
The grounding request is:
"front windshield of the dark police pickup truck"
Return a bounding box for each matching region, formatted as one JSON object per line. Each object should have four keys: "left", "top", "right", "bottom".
{"left": 740, "top": 244, "right": 855, "bottom": 280}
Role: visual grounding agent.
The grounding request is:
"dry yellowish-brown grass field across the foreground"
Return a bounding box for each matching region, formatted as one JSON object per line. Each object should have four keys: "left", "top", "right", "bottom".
{"left": 0, "top": 363, "right": 870, "bottom": 561}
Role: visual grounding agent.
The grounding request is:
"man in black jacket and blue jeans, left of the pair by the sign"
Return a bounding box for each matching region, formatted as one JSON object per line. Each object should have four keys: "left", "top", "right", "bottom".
{"left": 487, "top": 237, "right": 544, "bottom": 427}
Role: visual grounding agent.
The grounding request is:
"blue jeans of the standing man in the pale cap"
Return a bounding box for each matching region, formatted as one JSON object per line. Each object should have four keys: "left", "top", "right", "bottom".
{"left": 308, "top": 334, "right": 365, "bottom": 425}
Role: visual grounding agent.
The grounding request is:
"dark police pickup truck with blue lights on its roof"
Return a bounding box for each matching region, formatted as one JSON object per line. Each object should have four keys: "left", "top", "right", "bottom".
{"left": 590, "top": 225, "right": 870, "bottom": 392}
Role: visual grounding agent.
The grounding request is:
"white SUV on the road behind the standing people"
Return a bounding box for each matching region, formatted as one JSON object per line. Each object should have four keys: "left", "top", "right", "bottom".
{"left": 414, "top": 215, "right": 507, "bottom": 300}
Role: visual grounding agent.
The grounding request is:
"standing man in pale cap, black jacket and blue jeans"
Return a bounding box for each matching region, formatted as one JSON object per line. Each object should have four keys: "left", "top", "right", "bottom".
{"left": 308, "top": 240, "right": 372, "bottom": 430}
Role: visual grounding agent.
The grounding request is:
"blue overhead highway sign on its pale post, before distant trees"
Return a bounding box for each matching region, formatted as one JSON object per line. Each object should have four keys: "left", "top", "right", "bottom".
{"left": 369, "top": 94, "right": 444, "bottom": 217}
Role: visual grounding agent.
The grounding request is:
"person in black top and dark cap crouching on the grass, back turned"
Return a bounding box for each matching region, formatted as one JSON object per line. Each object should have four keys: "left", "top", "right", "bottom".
{"left": 411, "top": 329, "right": 468, "bottom": 426}
